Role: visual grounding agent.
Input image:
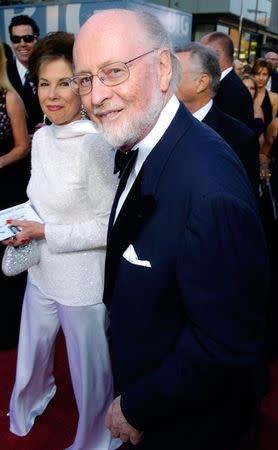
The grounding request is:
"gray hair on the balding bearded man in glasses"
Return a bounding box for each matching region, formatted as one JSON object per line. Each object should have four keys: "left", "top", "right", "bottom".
{"left": 136, "top": 11, "right": 181, "bottom": 92}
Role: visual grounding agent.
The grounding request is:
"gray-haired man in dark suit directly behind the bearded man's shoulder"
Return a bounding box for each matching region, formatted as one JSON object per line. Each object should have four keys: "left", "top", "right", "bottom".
{"left": 177, "top": 42, "right": 260, "bottom": 197}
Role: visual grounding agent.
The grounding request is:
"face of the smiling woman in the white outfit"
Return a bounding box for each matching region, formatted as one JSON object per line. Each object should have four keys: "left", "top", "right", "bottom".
{"left": 38, "top": 58, "right": 81, "bottom": 125}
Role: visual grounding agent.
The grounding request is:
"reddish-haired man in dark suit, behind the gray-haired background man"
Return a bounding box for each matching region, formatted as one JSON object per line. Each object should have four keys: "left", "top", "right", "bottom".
{"left": 201, "top": 31, "right": 254, "bottom": 129}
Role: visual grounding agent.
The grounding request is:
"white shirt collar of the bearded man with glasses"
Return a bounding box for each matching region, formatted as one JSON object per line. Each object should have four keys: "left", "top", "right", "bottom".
{"left": 133, "top": 95, "right": 180, "bottom": 176}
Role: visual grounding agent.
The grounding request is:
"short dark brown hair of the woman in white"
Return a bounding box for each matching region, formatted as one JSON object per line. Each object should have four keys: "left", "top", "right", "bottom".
{"left": 28, "top": 31, "right": 74, "bottom": 83}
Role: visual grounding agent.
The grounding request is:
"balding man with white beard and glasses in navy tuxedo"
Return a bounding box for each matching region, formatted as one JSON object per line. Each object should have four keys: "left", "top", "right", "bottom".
{"left": 74, "top": 9, "right": 268, "bottom": 450}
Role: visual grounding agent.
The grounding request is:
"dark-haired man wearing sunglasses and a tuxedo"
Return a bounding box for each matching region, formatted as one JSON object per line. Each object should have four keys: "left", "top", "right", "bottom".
{"left": 7, "top": 15, "right": 43, "bottom": 135}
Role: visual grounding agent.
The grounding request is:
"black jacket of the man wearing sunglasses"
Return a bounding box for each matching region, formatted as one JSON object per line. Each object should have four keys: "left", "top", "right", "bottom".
{"left": 7, "top": 60, "right": 43, "bottom": 134}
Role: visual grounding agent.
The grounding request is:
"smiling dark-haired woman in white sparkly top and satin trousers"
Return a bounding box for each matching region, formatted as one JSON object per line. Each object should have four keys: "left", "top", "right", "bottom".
{"left": 2, "top": 32, "right": 121, "bottom": 450}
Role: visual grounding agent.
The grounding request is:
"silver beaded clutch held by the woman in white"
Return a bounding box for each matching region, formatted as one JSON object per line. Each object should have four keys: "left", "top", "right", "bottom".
{"left": 2, "top": 240, "right": 40, "bottom": 277}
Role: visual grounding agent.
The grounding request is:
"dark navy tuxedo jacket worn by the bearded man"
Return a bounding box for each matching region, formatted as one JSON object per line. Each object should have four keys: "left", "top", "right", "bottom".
{"left": 104, "top": 106, "right": 268, "bottom": 450}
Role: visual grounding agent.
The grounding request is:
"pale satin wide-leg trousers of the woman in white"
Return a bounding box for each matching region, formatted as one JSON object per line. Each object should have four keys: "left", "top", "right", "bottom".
{"left": 10, "top": 279, "right": 122, "bottom": 450}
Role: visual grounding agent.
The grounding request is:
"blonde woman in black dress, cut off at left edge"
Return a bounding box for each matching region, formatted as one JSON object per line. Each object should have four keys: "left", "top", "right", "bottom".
{"left": 0, "top": 42, "right": 30, "bottom": 350}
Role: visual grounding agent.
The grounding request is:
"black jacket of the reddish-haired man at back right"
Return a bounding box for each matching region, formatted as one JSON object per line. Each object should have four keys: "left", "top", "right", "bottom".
{"left": 214, "top": 70, "right": 254, "bottom": 130}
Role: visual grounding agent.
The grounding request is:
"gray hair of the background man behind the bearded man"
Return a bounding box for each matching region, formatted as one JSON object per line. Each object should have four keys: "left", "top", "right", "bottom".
{"left": 178, "top": 42, "right": 221, "bottom": 97}
